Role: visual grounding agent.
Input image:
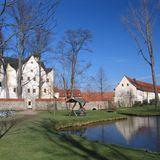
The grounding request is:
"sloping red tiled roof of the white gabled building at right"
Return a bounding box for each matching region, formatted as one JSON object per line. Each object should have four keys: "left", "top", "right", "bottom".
{"left": 125, "top": 76, "right": 160, "bottom": 92}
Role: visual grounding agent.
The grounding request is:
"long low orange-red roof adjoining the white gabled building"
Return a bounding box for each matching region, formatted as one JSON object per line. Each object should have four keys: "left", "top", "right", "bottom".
{"left": 81, "top": 92, "right": 115, "bottom": 102}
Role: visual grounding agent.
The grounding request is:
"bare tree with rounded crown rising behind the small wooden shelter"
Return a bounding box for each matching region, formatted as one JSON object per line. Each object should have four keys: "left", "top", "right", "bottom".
{"left": 57, "top": 29, "right": 92, "bottom": 97}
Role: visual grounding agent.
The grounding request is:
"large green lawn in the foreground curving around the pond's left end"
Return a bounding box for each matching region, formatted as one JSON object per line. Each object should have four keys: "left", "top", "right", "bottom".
{"left": 0, "top": 111, "right": 160, "bottom": 160}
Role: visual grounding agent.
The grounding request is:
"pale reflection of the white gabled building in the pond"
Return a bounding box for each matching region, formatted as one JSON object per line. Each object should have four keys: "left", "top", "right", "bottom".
{"left": 115, "top": 117, "right": 158, "bottom": 141}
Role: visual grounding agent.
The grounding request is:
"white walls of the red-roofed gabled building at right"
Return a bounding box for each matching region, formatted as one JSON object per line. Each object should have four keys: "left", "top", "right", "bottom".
{"left": 115, "top": 76, "right": 160, "bottom": 106}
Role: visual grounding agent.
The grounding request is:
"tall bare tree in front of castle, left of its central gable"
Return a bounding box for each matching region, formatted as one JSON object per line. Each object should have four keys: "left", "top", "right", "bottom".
{"left": 9, "top": 0, "right": 35, "bottom": 98}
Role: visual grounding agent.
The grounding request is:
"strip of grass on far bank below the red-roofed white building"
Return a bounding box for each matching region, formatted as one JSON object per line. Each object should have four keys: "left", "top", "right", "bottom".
{"left": 117, "top": 105, "right": 160, "bottom": 116}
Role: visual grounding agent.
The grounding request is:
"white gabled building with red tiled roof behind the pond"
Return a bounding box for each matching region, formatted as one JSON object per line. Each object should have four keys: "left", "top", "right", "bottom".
{"left": 114, "top": 76, "right": 160, "bottom": 106}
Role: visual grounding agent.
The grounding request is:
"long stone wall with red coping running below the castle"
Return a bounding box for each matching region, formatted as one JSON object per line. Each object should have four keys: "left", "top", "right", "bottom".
{"left": 0, "top": 99, "right": 113, "bottom": 110}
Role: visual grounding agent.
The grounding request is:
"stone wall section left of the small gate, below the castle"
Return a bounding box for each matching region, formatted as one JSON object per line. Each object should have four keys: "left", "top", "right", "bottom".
{"left": 0, "top": 99, "right": 27, "bottom": 110}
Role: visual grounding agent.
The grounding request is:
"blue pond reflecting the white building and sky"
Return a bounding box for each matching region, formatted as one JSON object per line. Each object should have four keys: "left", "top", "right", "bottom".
{"left": 63, "top": 116, "right": 160, "bottom": 152}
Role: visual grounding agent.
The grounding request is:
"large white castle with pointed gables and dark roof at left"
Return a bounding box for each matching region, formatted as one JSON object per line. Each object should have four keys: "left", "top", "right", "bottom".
{"left": 0, "top": 55, "right": 54, "bottom": 100}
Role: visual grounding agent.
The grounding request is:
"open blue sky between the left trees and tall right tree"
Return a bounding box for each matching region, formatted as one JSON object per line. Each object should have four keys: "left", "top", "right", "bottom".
{"left": 55, "top": 0, "right": 160, "bottom": 87}
